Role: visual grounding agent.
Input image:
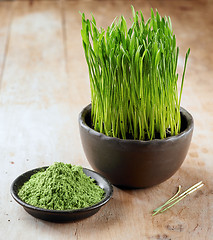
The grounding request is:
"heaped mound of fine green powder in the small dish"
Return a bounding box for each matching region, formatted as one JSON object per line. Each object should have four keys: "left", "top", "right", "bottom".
{"left": 18, "top": 162, "right": 104, "bottom": 210}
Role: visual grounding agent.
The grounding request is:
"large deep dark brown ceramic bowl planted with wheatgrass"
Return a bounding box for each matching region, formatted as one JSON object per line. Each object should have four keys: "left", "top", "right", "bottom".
{"left": 79, "top": 104, "right": 194, "bottom": 188}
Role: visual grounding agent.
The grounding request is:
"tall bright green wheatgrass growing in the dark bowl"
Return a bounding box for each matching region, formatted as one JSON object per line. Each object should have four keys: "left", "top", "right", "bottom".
{"left": 81, "top": 7, "right": 190, "bottom": 140}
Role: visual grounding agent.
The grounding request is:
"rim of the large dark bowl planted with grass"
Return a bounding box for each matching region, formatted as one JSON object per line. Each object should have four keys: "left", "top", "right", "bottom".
{"left": 78, "top": 103, "right": 194, "bottom": 144}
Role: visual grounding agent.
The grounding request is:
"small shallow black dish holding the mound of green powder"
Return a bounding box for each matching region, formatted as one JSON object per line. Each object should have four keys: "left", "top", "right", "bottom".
{"left": 10, "top": 167, "right": 113, "bottom": 222}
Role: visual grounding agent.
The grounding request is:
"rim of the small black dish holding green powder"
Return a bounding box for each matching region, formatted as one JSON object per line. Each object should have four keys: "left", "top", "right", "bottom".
{"left": 10, "top": 166, "right": 113, "bottom": 215}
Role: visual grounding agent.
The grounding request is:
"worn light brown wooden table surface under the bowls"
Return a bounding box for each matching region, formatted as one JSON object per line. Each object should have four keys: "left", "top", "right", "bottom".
{"left": 0, "top": 0, "right": 213, "bottom": 240}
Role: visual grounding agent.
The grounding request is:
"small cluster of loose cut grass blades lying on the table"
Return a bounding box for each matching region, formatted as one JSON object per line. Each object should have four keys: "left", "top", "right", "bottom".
{"left": 152, "top": 181, "right": 204, "bottom": 216}
